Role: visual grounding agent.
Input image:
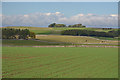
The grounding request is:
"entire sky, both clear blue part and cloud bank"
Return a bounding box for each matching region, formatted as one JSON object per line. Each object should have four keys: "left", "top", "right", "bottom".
{"left": 1, "top": 2, "right": 118, "bottom": 27}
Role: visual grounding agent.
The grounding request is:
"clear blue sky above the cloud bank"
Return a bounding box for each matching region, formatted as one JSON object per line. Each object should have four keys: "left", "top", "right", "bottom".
{"left": 2, "top": 2, "right": 118, "bottom": 16}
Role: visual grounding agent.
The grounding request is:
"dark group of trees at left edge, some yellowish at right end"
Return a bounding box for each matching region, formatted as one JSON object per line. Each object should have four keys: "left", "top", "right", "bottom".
{"left": 2, "top": 28, "right": 35, "bottom": 39}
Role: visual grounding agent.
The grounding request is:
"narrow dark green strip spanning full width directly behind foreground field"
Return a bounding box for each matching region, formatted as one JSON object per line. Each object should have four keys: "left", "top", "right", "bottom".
{"left": 2, "top": 40, "right": 119, "bottom": 47}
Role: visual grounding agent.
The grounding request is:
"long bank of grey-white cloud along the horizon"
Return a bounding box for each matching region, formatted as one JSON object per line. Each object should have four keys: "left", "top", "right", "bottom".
{"left": 0, "top": 12, "right": 118, "bottom": 27}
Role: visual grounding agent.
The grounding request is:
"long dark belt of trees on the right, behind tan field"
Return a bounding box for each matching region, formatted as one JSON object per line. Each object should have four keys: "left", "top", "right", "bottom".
{"left": 61, "top": 29, "right": 119, "bottom": 38}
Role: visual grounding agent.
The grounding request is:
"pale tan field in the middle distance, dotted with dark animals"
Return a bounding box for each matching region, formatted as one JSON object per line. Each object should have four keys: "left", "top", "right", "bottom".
{"left": 36, "top": 35, "right": 118, "bottom": 45}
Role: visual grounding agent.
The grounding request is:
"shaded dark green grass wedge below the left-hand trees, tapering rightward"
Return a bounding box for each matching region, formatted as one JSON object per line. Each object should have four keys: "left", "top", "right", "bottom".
{"left": 2, "top": 40, "right": 68, "bottom": 46}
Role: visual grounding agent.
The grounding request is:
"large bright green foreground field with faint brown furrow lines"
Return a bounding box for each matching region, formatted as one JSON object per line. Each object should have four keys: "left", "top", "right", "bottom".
{"left": 2, "top": 47, "right": 118, "bottom": 78}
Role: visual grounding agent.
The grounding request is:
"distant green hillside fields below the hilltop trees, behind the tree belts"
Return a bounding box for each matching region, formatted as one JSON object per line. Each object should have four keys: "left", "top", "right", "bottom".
{"left": 3, "top": 26, "right": 118, "bottom": 34}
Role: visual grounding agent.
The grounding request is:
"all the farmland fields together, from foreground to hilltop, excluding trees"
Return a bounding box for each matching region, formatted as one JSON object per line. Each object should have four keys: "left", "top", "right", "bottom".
{"left": 2, "top": 27, "right": 119, "bottom": 78}
